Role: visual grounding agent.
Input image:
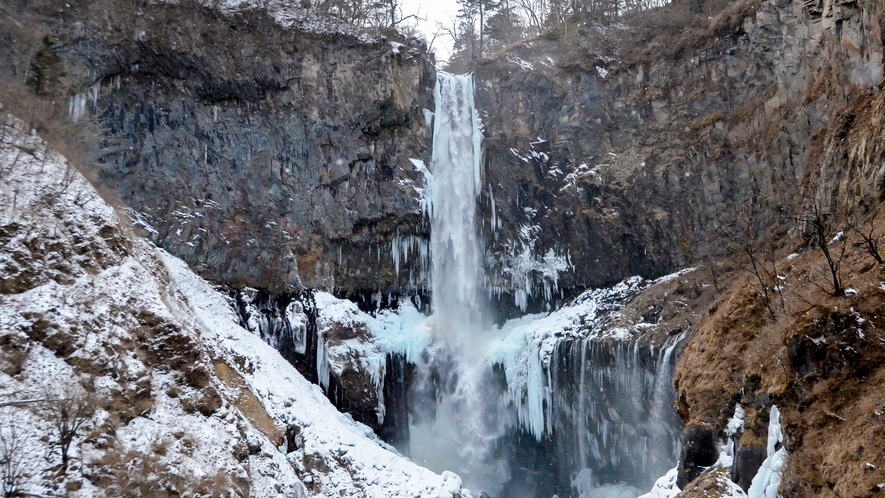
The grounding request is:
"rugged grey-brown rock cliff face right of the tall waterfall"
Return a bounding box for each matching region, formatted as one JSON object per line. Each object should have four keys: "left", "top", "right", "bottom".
{"left": 476, "top": 1, "right": 882, "bottom": 312}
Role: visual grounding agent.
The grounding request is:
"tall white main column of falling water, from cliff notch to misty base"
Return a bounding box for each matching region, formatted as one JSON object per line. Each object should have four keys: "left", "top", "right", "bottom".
{"left": 410, "top": 72, "right": 508, "bottom": 494}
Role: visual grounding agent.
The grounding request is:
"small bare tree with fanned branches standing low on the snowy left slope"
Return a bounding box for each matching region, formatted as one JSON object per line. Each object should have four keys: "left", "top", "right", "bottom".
{"left": 43, "top": 381, "right": 99, "bottom": 473}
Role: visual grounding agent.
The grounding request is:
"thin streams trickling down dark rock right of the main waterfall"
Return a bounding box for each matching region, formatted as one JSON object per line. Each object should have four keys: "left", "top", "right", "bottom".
{"left": 550, "top": 335, "right": 682, "bottom": 496}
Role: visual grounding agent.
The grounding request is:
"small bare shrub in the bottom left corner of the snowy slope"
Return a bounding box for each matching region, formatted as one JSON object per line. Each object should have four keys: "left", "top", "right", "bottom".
{"left": 0, "top": 420, "right": 39, "bottom": 498}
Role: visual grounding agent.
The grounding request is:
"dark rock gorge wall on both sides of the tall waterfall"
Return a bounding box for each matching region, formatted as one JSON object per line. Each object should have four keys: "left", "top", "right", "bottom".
{"left": 0, "top": 1, "right": 882, "bottom": 316}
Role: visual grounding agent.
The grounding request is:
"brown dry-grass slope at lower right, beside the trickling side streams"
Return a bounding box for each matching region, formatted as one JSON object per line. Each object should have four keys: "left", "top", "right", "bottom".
{"left": 675, "top": 205, "right": 885, "bottom": 497}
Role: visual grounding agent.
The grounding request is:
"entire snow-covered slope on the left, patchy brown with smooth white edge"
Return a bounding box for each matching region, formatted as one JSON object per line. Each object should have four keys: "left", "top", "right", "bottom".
{"left": 0, "top": 115, "right": 469, "bottom": 497}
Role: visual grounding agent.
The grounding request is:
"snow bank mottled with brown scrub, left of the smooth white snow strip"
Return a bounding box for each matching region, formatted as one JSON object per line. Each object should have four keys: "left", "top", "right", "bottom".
{"left": 0, "top": 115, "right": 305, "bottom": 497}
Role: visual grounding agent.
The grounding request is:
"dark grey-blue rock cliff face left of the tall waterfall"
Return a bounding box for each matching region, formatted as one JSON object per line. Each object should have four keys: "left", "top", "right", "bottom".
{"left": 4, "top": 2, "right": 434, "bottom": 295}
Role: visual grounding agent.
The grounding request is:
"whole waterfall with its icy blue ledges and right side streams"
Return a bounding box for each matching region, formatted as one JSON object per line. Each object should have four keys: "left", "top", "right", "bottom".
{"left": 234, "top": 72, "right": 690, "bottom": 498}
